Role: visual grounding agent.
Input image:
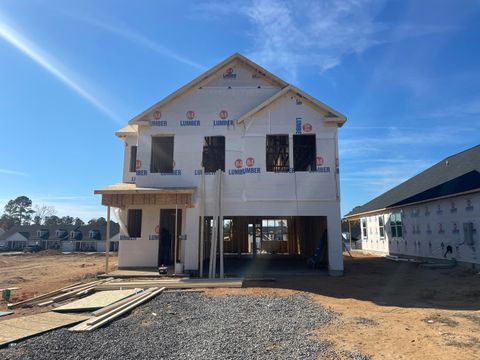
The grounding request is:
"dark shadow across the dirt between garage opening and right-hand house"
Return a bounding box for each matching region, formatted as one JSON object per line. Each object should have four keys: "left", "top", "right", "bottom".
{"left": 240, "top": 253, "right": 480, "bottom": 310}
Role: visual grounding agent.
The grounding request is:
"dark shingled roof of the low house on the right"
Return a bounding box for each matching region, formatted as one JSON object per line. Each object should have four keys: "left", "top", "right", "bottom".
{"left": 346, "top": 145, "right": 480, "bottom": 217}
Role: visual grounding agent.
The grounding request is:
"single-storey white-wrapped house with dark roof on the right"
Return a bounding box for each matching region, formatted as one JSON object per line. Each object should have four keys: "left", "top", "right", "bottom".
{"left": 346, "top": 145, "right": 480, "bottom": 264}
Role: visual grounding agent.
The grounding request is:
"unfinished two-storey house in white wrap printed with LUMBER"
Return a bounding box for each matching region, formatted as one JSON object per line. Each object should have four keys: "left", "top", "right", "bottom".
{"left": 95, "top": 54, "right": 346, "bottom": 274}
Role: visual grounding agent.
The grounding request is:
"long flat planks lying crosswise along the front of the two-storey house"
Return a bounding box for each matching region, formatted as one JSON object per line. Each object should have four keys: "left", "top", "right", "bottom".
{"left": 95, "top": 279, "right": 243, "bottom": 291}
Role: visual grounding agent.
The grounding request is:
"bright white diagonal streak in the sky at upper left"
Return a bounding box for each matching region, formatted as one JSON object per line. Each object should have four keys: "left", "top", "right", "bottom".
{"left": 0, "top": 17, "right": 122, "bottom": 124}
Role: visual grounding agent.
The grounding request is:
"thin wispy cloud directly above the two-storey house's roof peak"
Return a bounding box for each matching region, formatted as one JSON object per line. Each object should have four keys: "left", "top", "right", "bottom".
{"left": 197, "top": 0, "right": 458, "bottom": 81}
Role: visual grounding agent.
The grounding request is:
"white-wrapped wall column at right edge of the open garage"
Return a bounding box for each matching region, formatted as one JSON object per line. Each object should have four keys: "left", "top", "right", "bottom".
{"left": 327, "top": 203, "right": 343, "bottom": 276}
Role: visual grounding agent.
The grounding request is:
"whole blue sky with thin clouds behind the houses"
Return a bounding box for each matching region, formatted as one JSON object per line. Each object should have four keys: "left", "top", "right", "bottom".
{"left": 0, "top": 0, "right": 480, "bottom": 220}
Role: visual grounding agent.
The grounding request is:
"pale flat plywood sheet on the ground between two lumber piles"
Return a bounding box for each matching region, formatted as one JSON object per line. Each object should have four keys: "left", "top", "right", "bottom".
{"left": 53, "top": 289, "right": 138, "bottom": 312}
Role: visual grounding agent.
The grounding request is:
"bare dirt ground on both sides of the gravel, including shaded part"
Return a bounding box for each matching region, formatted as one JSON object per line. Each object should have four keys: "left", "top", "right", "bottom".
{"left": 0, "top": 253, "right": 480, "bottom": 360}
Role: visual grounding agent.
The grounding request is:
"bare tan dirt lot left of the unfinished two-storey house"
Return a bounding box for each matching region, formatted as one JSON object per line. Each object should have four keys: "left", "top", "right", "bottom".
{"left": 0, "top": 251, "right": 117, "bottom": 318}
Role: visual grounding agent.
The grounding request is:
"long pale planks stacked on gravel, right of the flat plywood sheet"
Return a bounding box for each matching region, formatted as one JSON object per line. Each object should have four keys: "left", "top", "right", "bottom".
{"left": 69, "top": 287, "right": 165, "bottom": 331}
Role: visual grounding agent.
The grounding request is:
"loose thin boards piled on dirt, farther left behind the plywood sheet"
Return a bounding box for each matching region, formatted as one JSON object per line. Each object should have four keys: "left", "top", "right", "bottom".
{"left": 7, "top": 278, "right": 113, "bottom": 309}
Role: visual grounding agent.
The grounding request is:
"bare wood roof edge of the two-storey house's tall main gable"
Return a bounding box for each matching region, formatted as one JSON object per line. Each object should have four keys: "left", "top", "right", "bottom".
{"left": 128, "top": 53, "right": 288, "bottom": 125}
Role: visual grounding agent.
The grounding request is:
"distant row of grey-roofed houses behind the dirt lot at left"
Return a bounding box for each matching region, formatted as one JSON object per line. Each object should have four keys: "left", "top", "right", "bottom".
{"left": 0, "top": 224, "right": 119, "bottom": 252}
